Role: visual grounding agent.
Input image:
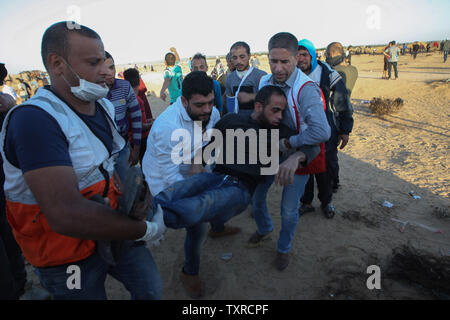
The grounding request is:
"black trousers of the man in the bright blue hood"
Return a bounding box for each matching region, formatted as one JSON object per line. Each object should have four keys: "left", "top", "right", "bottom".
{"left": 301, "top": 139, "right": 339, "bottom": 207}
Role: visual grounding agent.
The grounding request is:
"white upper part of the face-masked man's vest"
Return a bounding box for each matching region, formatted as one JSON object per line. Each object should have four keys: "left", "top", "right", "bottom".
{"left": 0, "top": 89, "right": 125, "bottom": 204}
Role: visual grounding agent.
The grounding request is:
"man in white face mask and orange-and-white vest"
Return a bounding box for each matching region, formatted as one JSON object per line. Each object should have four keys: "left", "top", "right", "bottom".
{"left": 0, "top": 22, "right": 165, "bottom": 300}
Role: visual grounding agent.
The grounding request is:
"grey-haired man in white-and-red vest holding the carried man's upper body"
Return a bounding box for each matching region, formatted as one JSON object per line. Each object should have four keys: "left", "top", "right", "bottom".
{"left": 248, "top": 32, "right": 330, "bottom": 271}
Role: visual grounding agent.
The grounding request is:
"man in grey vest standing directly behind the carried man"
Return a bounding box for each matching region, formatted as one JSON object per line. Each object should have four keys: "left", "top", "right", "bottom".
{"left": 225, "top": 41, "right": 267, "bottom": 114}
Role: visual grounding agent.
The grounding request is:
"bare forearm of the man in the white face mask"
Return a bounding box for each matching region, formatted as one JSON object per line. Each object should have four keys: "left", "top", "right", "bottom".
{"left": 24, "top": 166, "right": 146, "bottom": 240}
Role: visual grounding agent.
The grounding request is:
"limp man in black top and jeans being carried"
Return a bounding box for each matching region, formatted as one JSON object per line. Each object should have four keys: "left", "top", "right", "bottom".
{"left": 153, "top": 86, "right": 320, "bottom": 295}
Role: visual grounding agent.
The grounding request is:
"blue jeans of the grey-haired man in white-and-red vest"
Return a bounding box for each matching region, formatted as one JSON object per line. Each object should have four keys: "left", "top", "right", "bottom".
{"left": 252, "top": 174, "right": 309, "bottom": 253}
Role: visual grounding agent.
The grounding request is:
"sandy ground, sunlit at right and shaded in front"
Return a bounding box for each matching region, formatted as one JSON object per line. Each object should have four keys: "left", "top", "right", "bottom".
{"left": 26, "top": 53, "right": 450, "bottom": 300}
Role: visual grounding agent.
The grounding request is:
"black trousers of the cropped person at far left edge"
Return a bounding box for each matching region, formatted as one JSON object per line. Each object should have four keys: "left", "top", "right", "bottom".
{"left": 0, "top": 195, "right": 27, "bottom": 300}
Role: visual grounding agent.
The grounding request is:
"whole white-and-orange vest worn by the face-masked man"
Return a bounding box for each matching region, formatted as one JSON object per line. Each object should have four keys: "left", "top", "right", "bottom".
{"left": 0, "top": 89, "right": 125, "bottom": 267}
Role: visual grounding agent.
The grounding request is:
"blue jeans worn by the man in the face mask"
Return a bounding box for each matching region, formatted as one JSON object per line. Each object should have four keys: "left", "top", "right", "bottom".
{"left": 35, "top": 245, "right": 162, "bottom": 300}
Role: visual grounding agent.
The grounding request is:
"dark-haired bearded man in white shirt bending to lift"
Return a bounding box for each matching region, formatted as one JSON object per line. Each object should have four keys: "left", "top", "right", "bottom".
{"left": 142, "top": 71, "right": 240, "bottom": 297}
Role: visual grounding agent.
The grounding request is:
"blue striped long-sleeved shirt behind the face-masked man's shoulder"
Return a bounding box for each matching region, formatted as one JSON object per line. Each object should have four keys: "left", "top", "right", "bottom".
{"left": 106, "top": 79, "right": 142, "bottom": 146}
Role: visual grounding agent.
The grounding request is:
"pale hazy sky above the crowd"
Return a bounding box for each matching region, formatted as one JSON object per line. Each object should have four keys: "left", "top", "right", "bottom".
{"left": 0, "top": 0, "right": 450, "bottom": 73}
